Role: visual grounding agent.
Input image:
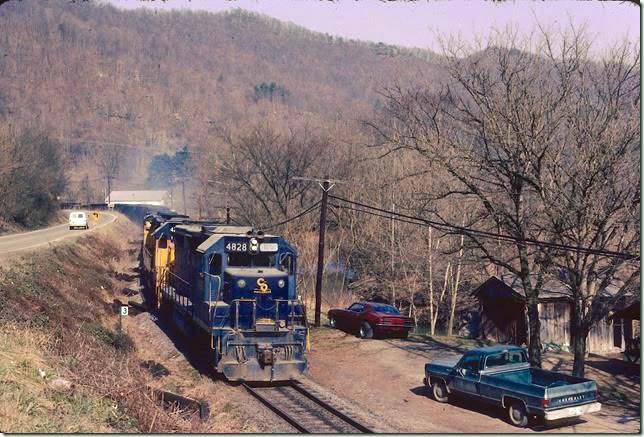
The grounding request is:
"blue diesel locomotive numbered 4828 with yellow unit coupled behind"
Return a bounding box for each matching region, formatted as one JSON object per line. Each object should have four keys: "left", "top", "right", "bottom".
{"left": 144, "top": 215, "right": 308, "bottom": 381}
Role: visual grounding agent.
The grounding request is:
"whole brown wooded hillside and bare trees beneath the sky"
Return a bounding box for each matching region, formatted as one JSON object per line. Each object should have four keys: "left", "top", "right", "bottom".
{"left": 0, "top": 1, "right": 641, "bottom": 374}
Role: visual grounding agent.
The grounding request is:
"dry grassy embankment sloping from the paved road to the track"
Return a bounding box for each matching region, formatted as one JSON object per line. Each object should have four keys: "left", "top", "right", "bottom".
{"left": 0, "top": 219, "right": 203, "bottom": 432}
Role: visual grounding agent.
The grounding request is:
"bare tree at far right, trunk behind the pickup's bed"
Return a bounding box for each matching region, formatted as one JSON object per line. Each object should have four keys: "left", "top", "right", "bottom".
{"left": 533, "top": 40, "right": 641, "bottom": 376}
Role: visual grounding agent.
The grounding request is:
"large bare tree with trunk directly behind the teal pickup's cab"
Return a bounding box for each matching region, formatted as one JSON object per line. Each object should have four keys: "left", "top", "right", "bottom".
{"left": 367, "top": 31, "right": 639, "bottom": 372}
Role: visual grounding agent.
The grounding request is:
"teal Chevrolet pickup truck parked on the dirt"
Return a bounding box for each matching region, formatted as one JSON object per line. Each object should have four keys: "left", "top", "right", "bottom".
{"left": 423, "top": 345, "right": 601, "bottom": 427}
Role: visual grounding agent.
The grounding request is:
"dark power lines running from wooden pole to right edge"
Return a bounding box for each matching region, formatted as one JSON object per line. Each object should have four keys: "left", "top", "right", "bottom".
{"left": 329, "top": 196, "right": 639, "bottom": 259}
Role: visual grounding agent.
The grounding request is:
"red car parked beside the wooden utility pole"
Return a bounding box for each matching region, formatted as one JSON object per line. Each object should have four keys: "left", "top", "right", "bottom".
{"left": 329, "top": 302, "right": 414, "bottom": 338}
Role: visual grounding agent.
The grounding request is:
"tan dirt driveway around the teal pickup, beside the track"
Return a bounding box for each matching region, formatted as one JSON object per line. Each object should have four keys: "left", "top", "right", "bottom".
{"left": 308, "top": 328, "right": 640, "bottom": 433}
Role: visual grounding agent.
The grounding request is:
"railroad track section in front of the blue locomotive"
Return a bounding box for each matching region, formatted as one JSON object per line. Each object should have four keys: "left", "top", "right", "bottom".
{"left": 242, "top": 381, "right": 373, "bottom": 434}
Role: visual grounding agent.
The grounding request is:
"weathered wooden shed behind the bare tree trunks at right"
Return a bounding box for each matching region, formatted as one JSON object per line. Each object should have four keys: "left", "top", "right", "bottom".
{"left": 472, "top": 273, "right": 632, "bottom": 354}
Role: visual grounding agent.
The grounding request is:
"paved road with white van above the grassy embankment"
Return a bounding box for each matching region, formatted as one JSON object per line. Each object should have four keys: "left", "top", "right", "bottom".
{"left": 0, "top": 211, "right": 116, "bottom": 255}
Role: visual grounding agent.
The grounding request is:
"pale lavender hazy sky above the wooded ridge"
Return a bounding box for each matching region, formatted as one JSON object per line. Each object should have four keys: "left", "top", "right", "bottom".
{"left": 108, "top": 0, "right": 640, "bottom": 50}
